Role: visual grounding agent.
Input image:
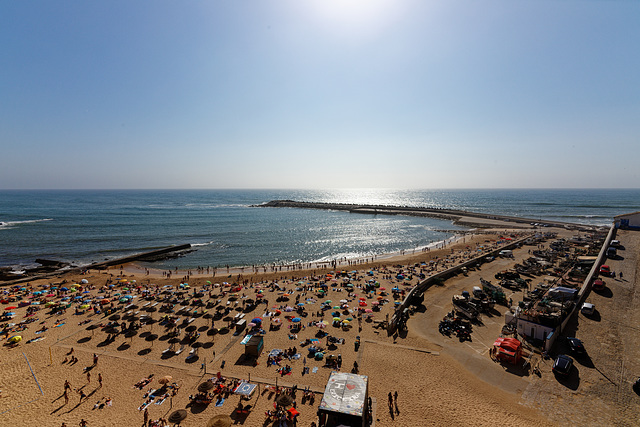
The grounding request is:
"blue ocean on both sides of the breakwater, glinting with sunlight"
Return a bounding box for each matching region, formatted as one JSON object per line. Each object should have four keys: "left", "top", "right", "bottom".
{"left": 0, "top": 189, "right": 640, "bottom": 270}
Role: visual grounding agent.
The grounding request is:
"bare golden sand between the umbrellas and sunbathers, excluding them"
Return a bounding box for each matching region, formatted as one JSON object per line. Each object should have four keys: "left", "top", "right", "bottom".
{"left": 0, "top": 234, "right": 548, "bottom": 427}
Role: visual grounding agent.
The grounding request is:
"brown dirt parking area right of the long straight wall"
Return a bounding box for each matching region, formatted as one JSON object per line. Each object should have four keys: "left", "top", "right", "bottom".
{"left": 522, "top": 230, "right": 640, "bottom": 426}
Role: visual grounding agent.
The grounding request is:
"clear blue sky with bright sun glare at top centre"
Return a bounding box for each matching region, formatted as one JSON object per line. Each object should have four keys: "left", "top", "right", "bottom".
{"left": 0, "top": 0, "right": 640, "bottom": 189}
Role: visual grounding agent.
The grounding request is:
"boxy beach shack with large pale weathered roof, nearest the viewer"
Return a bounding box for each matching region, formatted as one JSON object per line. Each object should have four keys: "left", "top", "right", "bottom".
{"left": 318, "top": 372, "right": 369, "bottom": 427}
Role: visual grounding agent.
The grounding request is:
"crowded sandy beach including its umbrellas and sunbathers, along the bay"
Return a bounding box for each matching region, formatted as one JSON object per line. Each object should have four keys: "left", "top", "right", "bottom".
{"left": 0, "top": 226, "right": 560, "bottom": 426}
